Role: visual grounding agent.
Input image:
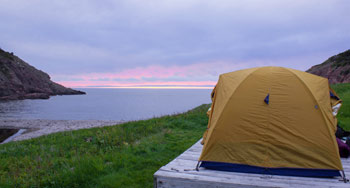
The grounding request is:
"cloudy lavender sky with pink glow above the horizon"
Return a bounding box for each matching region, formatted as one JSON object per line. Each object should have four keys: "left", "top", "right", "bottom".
{"left": 0, "top": 0, "right": 350, "bottom": 88}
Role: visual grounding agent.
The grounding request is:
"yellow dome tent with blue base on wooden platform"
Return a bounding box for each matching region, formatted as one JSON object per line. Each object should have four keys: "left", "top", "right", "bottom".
{"left": 199, "top": 67, "right": 343, "bottom": 176}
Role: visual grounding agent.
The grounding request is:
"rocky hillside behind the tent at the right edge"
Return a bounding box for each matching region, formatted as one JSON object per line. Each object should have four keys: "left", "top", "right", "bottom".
{"left": 306, "top": 50, "right": 350, "bottom": 84}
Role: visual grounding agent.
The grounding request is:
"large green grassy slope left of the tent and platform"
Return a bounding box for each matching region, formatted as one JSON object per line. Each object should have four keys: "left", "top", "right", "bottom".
{"left": 0, "top": 105, "right": 209, "bottom": 188}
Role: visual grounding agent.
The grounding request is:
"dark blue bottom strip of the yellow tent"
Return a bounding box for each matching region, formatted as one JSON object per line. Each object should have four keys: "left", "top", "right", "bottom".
{"left": 200, "top": 161, "right": 341, "bottom": 178}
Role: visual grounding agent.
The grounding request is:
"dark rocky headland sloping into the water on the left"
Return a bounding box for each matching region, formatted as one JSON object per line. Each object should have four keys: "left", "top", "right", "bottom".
{"left": 0, "top": 48, "right": 85, "bottom": 100}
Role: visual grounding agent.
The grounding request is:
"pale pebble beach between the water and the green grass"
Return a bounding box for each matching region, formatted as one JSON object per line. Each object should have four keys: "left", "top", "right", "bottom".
{"left": 0, "top": 119, "right": 123, "bottom": 141}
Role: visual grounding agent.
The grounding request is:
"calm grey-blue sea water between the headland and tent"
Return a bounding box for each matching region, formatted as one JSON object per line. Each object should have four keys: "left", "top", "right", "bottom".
{"left": 0, "top": 89, "right": 211, "bottom": 121}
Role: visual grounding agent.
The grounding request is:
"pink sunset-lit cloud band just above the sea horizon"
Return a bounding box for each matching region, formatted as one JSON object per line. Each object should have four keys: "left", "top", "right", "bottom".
{"left": 53, "top": 62, "right": 258, "bottom": 87}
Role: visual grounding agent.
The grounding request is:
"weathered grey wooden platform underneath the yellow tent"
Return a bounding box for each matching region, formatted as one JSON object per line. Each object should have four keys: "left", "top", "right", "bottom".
{"left": 154, "top": 141, "right": 350, "bottom": 188}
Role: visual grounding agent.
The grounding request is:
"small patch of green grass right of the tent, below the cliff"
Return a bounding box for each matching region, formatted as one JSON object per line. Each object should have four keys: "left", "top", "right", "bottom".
{"left": 331, "top": 83, "right": 350, "bottom": 131}
